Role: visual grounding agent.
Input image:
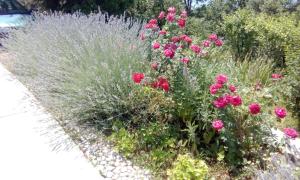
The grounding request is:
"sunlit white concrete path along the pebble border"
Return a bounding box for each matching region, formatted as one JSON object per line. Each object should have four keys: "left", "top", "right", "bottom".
{"left": 0, "top": 64, "right": 103, "bottom": 180}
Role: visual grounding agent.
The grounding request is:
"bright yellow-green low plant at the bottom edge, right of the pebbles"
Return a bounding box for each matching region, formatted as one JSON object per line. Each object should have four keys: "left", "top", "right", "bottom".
{"left": 168, "top": 155, "right": 208, "bottom": 180}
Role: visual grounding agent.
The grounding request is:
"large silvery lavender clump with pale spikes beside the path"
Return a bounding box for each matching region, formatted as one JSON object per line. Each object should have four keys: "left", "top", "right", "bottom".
{"left": 4, "top": 13, "right": 144, "bottom": 129}
